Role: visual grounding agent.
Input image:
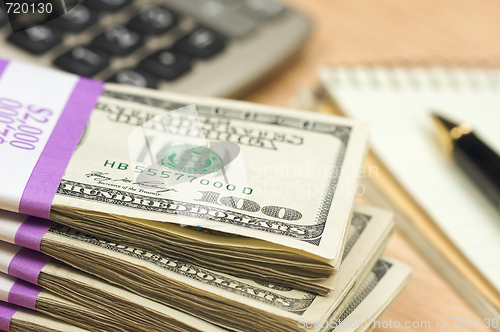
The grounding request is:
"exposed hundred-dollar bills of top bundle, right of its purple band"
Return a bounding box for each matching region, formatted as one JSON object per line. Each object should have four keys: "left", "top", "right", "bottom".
{"left": 50, "top": 85, "right": 367, "bottom": 290}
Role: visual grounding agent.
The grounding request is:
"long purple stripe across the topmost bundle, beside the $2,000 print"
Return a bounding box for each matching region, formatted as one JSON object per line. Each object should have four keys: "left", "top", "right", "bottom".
{"left": 15, "top": 70, "right": 104, "bottom": 219}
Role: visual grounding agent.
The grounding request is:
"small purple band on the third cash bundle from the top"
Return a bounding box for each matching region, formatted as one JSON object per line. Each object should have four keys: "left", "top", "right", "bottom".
{"left": 8, "top": 248, "right": 50, "bottom": 285}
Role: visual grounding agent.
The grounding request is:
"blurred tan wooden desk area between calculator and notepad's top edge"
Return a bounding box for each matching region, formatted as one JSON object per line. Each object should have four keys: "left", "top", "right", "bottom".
{"left": 247, "top": 0, "right": 500, "bottom": 106}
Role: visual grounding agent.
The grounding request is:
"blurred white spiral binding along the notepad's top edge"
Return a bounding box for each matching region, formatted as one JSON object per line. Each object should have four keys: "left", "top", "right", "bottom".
{"left": 322, "top": 66, "right": 500, "bottom": 92}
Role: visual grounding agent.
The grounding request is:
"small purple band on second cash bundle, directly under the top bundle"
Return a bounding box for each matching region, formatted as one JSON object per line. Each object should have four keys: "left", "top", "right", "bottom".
{"left": 14, "top": 217, "right": 53, "bottom": 251}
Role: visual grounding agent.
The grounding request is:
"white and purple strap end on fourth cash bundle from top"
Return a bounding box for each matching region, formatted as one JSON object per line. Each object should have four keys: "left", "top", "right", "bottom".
{"left": 0, "top": 273, "right": 42, "bottom": 309}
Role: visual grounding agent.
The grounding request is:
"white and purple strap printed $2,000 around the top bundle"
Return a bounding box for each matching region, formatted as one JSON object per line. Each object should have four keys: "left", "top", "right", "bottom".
{"left": 0, "top": 59, "right": 104, "bottom": 218}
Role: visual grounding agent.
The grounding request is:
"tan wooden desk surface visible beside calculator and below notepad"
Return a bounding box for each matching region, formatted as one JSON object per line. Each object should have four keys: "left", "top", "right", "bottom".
{"left": 247, "top": 0, "right": 500, "bottom": 331}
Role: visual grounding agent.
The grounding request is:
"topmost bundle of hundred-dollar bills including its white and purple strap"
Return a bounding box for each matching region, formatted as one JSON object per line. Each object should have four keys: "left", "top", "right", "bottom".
{"left": 0, "top": 59, "right": 367, "bottom": 287}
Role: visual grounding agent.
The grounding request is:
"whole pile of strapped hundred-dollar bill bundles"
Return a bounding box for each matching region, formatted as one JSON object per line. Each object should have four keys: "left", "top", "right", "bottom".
{"left": 0, "top": 60, "right": 411, "bottom": 332}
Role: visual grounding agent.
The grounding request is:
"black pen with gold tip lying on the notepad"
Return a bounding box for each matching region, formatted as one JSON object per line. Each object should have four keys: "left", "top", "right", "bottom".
{"left": 432, "top": 114, "right": 500, "bottom": 208}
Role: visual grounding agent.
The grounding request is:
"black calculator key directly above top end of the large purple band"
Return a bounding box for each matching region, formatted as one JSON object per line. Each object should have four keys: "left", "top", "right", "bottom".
{"left": 54, "top": 46, "right": 109, "bottom": 77}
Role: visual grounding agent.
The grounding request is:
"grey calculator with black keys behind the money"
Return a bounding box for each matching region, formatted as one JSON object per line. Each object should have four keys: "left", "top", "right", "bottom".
{"left": 0, "top": 0, "right": 311, "bottom": 97}
